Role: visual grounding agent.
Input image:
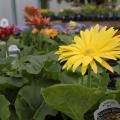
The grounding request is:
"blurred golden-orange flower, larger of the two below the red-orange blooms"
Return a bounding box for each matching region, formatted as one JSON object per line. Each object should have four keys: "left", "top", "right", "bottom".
{"left": 41, "top": 28, "right": 58, "bottom": 38}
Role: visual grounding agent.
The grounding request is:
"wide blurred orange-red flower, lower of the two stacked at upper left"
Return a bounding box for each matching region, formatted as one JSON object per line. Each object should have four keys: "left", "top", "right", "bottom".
{"left": 26, "top": 16, "right": 50, "bottom": 26}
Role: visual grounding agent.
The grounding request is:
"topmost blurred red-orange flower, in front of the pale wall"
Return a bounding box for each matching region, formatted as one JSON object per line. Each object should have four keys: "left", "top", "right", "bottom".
{"left": 24, "top": 6, "right": 40, "bottom": 16}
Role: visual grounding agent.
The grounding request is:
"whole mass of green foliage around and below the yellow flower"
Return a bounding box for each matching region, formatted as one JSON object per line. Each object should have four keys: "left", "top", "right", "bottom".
{"left": 0, "top": 26, "right": 120, "bottom": 120}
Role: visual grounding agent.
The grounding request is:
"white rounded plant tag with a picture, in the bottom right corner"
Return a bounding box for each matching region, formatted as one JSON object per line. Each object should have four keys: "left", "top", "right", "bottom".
{"left": 94, "top": 100, "right": 120, "bottom": 120}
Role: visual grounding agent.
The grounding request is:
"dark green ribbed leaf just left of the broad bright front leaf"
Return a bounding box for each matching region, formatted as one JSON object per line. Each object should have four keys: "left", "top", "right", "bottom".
{"left": 15, "top": 86, "right": 43, "bottom": 120}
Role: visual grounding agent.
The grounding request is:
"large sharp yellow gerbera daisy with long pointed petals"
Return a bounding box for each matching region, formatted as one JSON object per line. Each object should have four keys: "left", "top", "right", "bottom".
{"left": 56, "top": 25, "right": 120, "bottom": 75}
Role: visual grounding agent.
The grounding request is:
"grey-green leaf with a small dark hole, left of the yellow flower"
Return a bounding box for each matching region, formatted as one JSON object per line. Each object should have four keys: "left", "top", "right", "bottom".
{"left": 13, "top": 55, "right": 47, "bottom": 74}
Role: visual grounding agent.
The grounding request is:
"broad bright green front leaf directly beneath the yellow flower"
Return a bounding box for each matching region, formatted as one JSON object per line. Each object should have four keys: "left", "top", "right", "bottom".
{"left": 42, "top": 84, "right": 104, "bottom": 120}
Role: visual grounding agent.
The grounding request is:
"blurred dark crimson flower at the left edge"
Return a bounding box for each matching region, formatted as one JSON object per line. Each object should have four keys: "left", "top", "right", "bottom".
{"left": 0, "top": 25, "right": 19, "bottom": 40}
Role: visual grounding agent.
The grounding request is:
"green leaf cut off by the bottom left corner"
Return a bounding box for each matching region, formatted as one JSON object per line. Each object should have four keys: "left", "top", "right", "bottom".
{"left": 0, "top": 95, "right": 10, "bottom": 120}
